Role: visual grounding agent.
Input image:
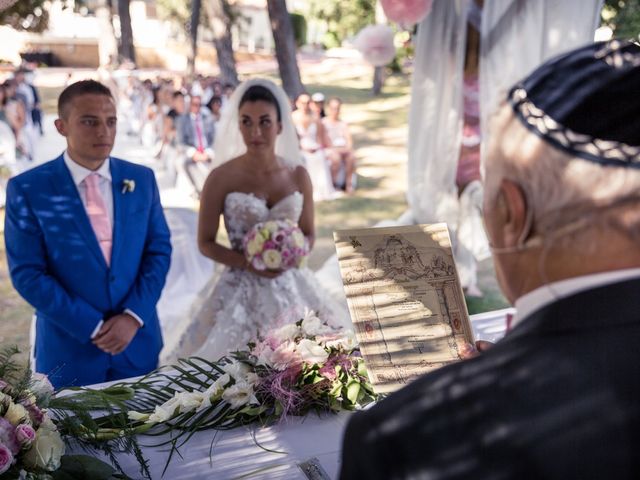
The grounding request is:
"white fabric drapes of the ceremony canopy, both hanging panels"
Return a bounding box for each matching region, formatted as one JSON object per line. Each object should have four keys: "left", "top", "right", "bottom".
{"left": 407, "top": 0, "right": 603, "bottom": 287}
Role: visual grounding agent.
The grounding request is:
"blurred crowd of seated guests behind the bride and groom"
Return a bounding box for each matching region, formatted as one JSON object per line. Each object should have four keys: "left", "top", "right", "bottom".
{"left": 0, "top": 68, "right": 356, "bottom": 206}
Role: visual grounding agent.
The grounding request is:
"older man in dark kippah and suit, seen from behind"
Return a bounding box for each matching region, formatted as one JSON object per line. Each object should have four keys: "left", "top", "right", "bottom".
{"left": 341, "top": 41, "right": 640, "bottom": 480}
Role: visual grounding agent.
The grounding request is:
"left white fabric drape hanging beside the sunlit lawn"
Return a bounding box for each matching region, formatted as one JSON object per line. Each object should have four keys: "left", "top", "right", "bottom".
{"left": 407, "top": 0, "right": 468, "bottom": 228}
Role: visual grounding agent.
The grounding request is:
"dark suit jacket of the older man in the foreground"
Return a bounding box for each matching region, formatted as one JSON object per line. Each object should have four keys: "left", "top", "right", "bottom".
{"left": 340, "top": 279, "right": 640, "bottom": 480}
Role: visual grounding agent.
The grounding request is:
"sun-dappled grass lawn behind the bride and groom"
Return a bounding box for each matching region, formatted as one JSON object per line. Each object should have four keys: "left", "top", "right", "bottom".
{"left": 0, "top": 65, "right": 507, "bottom": 354}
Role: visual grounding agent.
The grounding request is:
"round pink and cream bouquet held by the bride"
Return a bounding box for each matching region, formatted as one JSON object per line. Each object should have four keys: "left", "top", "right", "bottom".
{"left": 243, "top": 220, "right": 309, "bottom": 270}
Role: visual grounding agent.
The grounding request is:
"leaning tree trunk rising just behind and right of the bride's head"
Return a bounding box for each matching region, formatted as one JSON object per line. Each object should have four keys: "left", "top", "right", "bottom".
{"left": 267, "top": 0, "right": 305, "bottom": 98}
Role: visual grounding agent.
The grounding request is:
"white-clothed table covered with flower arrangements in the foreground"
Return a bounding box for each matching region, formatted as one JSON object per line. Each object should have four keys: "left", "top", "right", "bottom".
{"left": 0, "top": 310, "right": 510, "bottom": 480}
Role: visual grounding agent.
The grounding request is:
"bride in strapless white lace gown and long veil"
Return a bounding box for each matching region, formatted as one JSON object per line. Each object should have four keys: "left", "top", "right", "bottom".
{"left": 162, "top": 79, "right": 350, "bottom": 363}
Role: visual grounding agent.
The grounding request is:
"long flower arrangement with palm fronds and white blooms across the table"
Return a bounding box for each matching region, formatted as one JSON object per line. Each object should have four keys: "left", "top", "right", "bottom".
{"left": 53, "top": 311, "right": 376, "bottom": 476}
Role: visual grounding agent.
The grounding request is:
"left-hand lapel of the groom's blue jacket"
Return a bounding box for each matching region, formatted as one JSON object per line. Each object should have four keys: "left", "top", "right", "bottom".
{"left": 51, "top": 156, "right": 107, "bottom": 268}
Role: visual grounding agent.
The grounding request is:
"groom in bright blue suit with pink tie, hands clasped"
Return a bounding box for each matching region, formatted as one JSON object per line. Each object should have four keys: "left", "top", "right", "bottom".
{"left": 5, "top": 80, "right": 171, "bottom": 388}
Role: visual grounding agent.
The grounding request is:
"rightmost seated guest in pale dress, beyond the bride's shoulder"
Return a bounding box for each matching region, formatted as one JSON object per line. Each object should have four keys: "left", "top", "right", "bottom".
{"left": 322, "top": 97, "right": 356, "bottom": 193}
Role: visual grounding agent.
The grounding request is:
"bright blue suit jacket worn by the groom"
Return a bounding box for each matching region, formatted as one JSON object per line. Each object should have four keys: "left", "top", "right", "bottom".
{"left": 5, "top": 156, "right": 171, "bottom": 386}
